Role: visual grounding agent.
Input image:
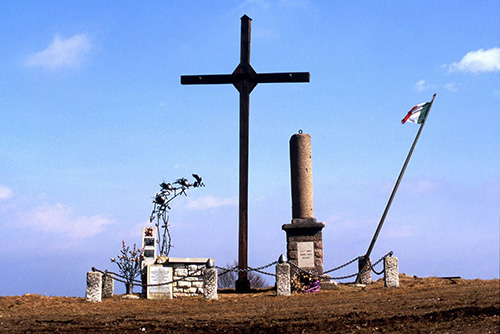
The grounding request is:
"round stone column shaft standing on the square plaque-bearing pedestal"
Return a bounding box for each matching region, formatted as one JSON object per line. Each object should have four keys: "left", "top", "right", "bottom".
{"left": 290, "top": 133, "right": 314, "bottom": 219}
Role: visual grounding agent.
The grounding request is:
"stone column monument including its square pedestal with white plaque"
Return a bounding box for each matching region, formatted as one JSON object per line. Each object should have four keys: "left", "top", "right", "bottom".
{"left": 282, "top": 131, "right": 325, "bottom": 275}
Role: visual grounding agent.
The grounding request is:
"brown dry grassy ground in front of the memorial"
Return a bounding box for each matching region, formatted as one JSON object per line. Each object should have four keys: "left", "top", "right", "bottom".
{"left": 0, "top": 275, "right": 500, "bottom": 334}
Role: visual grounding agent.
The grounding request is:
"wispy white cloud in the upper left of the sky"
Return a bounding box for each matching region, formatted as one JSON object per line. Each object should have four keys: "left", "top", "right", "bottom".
{"left": 26, "top": 34, "right": 91, "bottom": 69}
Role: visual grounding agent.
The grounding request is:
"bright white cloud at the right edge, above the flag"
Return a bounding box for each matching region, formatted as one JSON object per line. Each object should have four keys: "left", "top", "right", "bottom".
{"left": 449, "top": 48, "right": 500, "bottom": 73}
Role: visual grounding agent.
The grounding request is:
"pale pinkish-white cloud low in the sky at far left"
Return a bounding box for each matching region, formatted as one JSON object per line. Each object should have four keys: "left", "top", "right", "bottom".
{"left": 20, "top": 203, "right": 113, "bottom": 239}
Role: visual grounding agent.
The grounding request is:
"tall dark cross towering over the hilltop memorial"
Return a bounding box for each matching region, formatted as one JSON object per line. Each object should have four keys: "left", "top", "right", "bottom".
{"left": 181, "top": 15, "right": 309, "bottom": 292}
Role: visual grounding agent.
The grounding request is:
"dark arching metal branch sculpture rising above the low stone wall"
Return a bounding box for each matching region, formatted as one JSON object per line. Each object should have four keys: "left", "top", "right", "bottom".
{"left": 149, "top": 174, "right": 205, "bottom": 256}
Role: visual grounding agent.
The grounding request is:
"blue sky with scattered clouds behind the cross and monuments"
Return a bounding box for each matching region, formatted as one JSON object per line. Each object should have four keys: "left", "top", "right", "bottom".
{"left": 0, "top": 0, "right": 500, "bottom": 297}
